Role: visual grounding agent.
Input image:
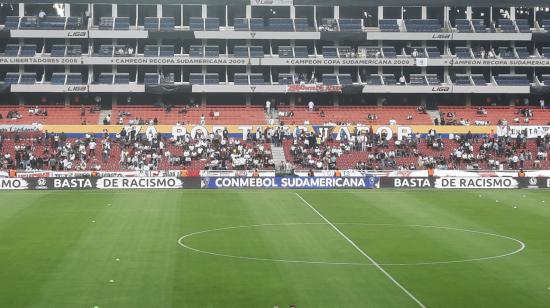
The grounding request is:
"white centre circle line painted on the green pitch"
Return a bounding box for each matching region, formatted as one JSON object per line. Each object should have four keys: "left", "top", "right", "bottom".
{"left": 178, "top": 222, "right": 526, "bottom": 266}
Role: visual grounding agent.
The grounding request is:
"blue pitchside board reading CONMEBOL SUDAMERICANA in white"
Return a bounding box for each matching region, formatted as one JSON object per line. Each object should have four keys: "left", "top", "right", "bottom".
{"left": 201, "top": 176, "right": 379, "bottom": 189}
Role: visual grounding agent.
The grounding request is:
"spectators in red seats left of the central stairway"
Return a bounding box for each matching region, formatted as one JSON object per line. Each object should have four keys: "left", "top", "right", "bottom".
{"left": 0, "top": 128, "right": 282, "bottom": 171}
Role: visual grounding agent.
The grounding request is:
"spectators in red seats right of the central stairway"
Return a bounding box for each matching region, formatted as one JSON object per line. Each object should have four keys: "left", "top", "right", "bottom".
{"left": 289, "top": 129, "right": 550, "bottom": 170}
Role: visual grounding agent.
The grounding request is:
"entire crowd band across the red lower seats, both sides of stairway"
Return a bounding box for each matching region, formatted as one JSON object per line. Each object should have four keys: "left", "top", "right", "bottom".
{"left": 0, "top": 122, "right": 550, "bottom": 171}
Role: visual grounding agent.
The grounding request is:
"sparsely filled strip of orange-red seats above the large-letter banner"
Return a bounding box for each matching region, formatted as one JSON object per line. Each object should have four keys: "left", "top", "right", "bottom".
{"left": 0, "top": 105, "right": 550, "bottom": 125}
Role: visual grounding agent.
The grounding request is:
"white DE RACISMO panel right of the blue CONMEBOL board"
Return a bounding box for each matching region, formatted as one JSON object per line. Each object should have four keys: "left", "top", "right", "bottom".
{"left": 435, "top": 177, "right": 519, "bottom": 189}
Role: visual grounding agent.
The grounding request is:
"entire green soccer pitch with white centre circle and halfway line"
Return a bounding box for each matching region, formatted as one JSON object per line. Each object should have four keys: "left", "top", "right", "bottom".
{"left": 0, "top": 190, "right": 550, "bottom": 308}
